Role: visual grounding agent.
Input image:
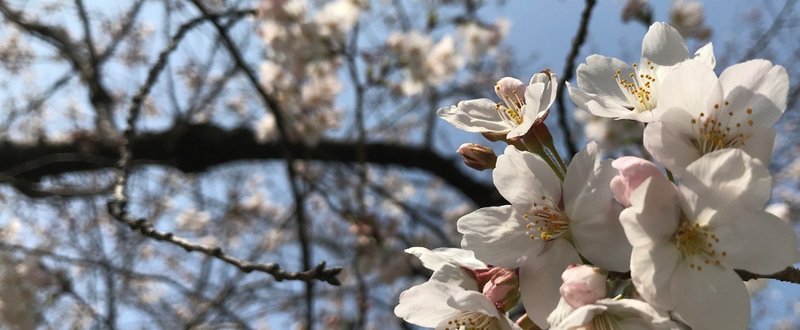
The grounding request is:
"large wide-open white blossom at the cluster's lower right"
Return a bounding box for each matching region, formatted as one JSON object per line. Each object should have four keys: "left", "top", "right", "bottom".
{"left": 615, "top": 149, "right": 800, "bottom": 329}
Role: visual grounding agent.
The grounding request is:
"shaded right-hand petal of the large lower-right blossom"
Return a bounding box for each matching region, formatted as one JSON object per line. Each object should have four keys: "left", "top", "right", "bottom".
{"left": 708, "top": 209, "right": 800, "bottom": 274}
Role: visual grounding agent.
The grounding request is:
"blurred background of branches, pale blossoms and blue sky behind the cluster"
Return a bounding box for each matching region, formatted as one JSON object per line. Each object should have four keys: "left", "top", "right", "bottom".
{"left": 0, "top": 0, "right": 800, "bottom": 329}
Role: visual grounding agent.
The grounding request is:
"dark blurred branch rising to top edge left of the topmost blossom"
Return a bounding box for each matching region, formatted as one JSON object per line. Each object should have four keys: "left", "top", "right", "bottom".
{"left": 556, "top": 0, "right": 596, "bottom": 157}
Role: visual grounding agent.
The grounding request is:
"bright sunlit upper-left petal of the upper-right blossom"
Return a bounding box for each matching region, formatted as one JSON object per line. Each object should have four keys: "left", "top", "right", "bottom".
{"left": 658, "top": 61, "right": 723, "bottom": 120}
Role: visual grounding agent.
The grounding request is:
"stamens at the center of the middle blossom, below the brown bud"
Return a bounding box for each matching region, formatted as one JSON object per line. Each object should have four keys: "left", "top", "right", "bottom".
{"left": 522, "top": 196, "right": 569, "bottom": 241}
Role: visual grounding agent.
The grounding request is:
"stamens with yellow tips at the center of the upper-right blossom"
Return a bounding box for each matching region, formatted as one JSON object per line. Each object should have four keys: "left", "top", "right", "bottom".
{"left": 691, "top": 101, "right": 753, "bottom": 155}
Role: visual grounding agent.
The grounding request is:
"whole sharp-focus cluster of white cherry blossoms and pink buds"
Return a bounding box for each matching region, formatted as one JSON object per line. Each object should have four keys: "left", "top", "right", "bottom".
{"left": 395, "top": 23, "right": 800, "bottom": 329}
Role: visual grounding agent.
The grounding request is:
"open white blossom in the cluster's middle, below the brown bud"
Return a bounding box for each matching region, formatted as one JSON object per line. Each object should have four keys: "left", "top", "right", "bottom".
{"left": 458, "top": 143, "right": 631, "bottom": 327}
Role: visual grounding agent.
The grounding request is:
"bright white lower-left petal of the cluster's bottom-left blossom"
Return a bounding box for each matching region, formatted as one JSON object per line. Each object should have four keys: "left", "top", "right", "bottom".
{"left": 394, "top": 281, "right": 465, "bottom": 328}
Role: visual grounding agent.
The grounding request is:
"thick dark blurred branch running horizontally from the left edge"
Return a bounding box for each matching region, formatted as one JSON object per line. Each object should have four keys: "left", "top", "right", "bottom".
{"left": 0, "top": 124, "right": 503, "bottom": 206}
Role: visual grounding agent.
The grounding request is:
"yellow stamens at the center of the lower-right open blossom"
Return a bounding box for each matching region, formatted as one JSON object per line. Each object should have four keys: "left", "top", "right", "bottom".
{"left": 673, "top": 220, "right": 727, "bottom": 271}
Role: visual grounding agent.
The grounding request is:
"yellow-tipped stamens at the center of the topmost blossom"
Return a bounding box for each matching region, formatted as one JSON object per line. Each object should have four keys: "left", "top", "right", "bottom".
{"left": 614, "top": 61, "right": 657, "bottom": 112}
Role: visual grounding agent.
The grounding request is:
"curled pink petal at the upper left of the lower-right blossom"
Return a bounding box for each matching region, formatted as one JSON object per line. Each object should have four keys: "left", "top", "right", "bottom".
{"left": 611, "top": 156, "right": 663, "bottom": 207}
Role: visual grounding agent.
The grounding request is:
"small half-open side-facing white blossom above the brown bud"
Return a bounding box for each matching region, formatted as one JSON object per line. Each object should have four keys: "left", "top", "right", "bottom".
{"left": 437, "top": 70, "right": 558, "bottom": 139}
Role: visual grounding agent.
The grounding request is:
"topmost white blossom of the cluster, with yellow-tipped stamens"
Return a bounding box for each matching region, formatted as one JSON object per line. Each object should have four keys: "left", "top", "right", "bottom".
{"left": 567, "top": 22, "right": 716, "bottom": 122}
